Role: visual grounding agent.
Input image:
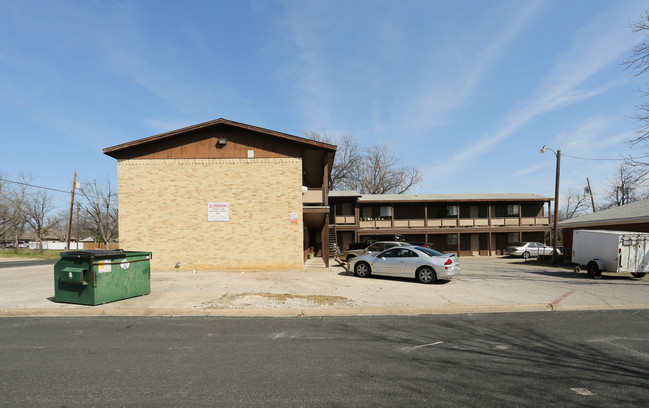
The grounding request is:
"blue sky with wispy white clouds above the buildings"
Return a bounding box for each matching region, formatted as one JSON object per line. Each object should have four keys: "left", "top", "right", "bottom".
{"left": 0, "top": 0, "right": 649, "bottom": 214}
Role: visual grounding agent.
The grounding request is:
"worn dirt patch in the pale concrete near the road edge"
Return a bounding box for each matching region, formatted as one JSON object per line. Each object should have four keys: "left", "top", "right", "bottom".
{"left": 200, "top": 292, "right": 353, "bottom": 309}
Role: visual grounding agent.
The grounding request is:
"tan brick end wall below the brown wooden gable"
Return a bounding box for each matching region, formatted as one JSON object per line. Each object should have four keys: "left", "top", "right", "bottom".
{"left": 117, "top": 158, "right": 304, "bottom": 270}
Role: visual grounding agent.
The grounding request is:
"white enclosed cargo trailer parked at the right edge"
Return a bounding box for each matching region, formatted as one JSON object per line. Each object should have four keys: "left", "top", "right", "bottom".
{"left": 572, "top": 230, "right": 649, "bottom": 278}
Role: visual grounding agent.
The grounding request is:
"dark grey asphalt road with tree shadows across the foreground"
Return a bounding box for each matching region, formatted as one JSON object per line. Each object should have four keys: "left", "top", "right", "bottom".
{"left": 0, "top": 311, "right": 649, "bottom": 407}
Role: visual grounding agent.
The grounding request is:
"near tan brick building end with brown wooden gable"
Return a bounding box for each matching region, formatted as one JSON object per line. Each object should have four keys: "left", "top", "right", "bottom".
{"left": 104, "top": 119, "right": 336, "bottom": 270}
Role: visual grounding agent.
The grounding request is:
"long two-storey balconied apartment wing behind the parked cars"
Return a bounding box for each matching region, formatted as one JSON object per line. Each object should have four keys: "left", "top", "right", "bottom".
{"left": 329, "top": 191, "right": 553, "bottom": 256}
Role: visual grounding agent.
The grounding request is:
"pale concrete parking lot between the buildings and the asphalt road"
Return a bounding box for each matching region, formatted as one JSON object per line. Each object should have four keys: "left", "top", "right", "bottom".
{"left": 0, "top": 257, "right": 649, "bottom": 316}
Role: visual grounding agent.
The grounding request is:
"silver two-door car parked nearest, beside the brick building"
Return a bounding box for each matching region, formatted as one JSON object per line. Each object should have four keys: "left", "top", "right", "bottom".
{"left": 350, "top": 247, "right": 460, "bottom": 283}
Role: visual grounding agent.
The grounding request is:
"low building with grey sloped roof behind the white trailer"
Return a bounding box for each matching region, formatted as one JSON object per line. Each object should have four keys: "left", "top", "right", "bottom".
{"left": 559, "top": 200, "right": 649, "bottom": 260}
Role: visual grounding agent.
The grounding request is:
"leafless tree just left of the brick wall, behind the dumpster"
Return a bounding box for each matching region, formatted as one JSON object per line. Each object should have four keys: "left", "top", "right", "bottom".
{"left": 80, "top": 180, "right": 118, "bottom": 248}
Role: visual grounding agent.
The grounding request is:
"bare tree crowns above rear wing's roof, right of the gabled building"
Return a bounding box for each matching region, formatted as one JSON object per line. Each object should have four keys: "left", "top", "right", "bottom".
{"left": 305, "top": 131, "right": 423, "bottom": 194}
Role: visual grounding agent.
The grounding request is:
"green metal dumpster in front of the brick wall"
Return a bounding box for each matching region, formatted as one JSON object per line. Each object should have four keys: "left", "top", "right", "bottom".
{"left": 54, "top": 249, "right": 151, "bottom": 305}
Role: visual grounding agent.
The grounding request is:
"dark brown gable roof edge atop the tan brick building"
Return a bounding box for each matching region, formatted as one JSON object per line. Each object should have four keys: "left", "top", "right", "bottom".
{"left": 103, "top": 118, "right": 336, "bottom": 158}
